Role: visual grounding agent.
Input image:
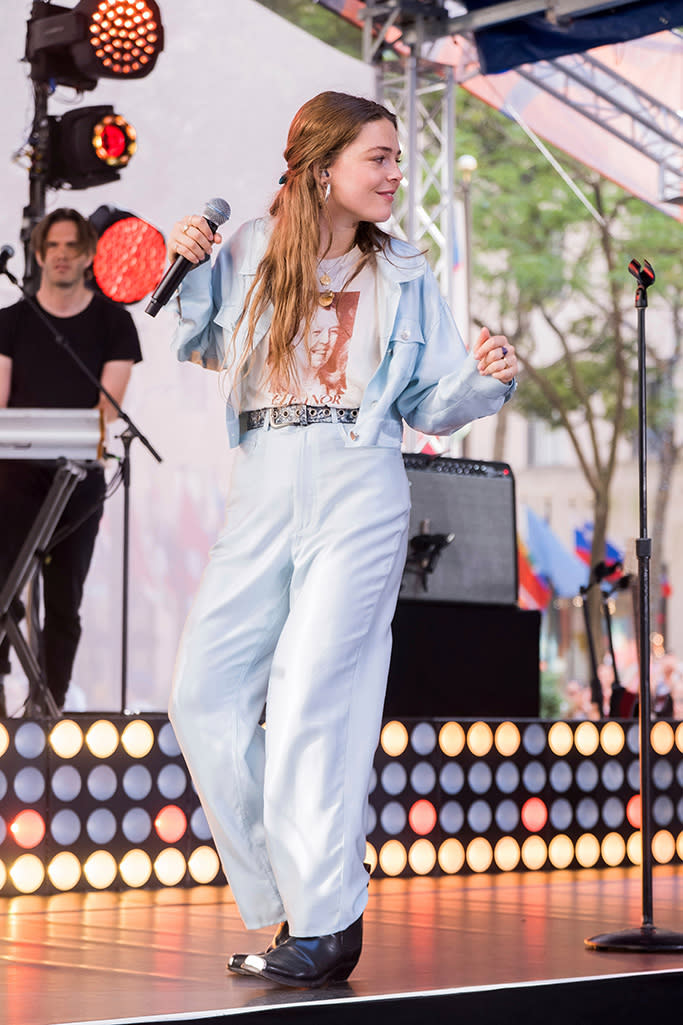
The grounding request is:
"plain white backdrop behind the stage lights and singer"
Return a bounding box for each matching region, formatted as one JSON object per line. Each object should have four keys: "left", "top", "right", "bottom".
{"left": 0, "top": 0, "right": 373, "bottom": 711}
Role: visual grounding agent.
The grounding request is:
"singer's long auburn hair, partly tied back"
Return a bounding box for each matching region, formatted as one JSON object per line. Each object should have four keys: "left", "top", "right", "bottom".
{"left": 233, "top": 91, "right": 397, "bottom": 387}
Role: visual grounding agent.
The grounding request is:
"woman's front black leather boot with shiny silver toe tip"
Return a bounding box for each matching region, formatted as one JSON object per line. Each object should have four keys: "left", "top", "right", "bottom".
{"left": 236, "top": 915, "right": 363, "bottom": 989}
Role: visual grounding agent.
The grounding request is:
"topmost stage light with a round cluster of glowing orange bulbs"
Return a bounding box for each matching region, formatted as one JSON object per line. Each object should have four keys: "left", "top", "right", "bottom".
{"left": 26, "top": 0, "right": 164, "bottom": 91}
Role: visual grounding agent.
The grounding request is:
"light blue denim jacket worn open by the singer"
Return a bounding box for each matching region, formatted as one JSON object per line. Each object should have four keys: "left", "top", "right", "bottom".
{"left": 173, "top": 218, "right": 515, "bottom": 448}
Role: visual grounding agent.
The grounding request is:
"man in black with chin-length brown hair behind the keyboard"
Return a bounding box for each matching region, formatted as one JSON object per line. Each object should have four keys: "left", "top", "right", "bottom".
{"left": 0, "top": 208, "right": 142, "bottom": 715}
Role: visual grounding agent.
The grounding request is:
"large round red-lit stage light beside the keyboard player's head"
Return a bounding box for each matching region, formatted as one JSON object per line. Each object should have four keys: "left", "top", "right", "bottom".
{"left": 89, "top": 206, "right": 166, "bottom": 303}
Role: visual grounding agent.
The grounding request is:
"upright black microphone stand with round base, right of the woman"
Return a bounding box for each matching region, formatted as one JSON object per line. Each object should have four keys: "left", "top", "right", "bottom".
{"left": 584, "top": 259, "right": 683, "bottom": 953}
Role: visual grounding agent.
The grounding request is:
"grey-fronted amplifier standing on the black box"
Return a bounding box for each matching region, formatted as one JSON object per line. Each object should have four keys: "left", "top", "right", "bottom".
{"left": 400, "top": 454, "right": 517, "bottom": 605}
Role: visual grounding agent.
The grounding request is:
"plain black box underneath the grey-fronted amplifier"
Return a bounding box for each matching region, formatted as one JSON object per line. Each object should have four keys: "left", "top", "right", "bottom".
{"left": 385, "top": 599, "right": 540, "bottom": 719}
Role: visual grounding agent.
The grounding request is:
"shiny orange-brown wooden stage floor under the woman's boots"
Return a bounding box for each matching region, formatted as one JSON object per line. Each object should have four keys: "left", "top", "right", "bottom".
{"left": 0, "top": 866, "right": 683, "bottom": 1025}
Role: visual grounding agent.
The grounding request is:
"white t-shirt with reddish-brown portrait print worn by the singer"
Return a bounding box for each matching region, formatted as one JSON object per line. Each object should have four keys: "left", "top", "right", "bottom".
{"left": 242, "top": 247, "right": 379, "bottom": 410}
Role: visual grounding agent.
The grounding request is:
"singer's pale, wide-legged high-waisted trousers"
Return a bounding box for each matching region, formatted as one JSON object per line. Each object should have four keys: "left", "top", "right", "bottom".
{"left": 170, "top": 423, "right": 409, "bottom": 936}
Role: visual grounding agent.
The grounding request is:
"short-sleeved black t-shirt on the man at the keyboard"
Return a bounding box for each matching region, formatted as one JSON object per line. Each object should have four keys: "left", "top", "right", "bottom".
{"left": 0, "top": 293, "right": 143, "bottom": 409}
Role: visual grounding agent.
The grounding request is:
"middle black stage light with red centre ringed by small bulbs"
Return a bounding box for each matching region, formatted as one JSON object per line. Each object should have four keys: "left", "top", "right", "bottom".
{"left": 46, "top": 106, "right": 137, "bottom": 189}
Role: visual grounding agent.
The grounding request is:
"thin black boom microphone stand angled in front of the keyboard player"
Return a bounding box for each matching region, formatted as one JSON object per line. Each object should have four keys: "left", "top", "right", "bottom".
{"left": 0, "top": 253, "right": 162, "bottom": 713}
